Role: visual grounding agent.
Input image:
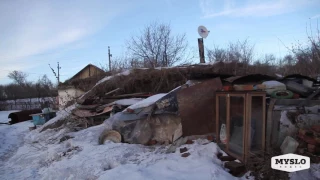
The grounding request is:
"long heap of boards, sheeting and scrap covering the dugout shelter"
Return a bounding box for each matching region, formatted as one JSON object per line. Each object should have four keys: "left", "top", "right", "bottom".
{"left": 55, "top": 66, "right": 320, "bottom": 177}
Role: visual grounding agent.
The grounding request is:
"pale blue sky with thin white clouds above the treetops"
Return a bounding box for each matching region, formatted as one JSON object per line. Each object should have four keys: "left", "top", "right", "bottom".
{"left": 0, "top": 0, "right": 320, "bottom": 84}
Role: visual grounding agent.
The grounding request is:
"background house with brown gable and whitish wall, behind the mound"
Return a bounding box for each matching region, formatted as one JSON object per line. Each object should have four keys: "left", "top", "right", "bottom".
{"left": 58, "top": 64, "right": 106, "bottom": 109}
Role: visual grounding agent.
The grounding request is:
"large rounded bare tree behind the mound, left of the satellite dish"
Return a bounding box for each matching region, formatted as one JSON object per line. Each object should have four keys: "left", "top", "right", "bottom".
{"left": 127, "top": 22, "right": 188, "bottom": 67}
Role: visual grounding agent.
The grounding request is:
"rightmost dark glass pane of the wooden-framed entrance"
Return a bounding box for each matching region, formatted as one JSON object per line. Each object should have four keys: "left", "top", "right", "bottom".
{"left": 249, "top": 96, "right": 263, "bottom": 151}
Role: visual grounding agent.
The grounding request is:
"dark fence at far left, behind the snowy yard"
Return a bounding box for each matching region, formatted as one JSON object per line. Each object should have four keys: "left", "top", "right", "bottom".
{"left": 0, "top": 97, "right": 57, "bottom": 111}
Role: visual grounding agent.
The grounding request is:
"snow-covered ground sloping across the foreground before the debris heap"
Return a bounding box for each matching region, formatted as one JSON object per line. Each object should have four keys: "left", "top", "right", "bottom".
{"left": 0, "top": 112, "right": 318, "bottom": 180}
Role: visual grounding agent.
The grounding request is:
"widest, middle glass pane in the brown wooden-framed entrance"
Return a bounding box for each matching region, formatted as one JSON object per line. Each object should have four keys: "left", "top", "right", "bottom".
{"left": 229, "top": 96, "right": 244, "bottom": 156}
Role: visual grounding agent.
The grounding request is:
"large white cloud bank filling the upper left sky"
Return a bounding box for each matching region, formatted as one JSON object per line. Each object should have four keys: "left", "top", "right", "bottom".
{"left": 0, "top": 0, "right": 131, "bottom": 81}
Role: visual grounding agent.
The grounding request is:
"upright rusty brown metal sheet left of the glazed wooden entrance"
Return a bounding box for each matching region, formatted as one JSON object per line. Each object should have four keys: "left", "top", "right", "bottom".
{"left": 177, "top": 78, "right": 222, "bottom": 136}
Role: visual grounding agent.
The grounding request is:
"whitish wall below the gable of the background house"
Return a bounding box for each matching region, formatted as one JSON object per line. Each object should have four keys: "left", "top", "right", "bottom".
{"left": 58, "top": 87, "right": 84, "bottom": 110}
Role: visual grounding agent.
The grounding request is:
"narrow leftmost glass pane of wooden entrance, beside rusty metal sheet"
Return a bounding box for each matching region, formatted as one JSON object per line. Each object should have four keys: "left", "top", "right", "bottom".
{"left": 218, "top": 96, "right": 227, "bottom": 148}
